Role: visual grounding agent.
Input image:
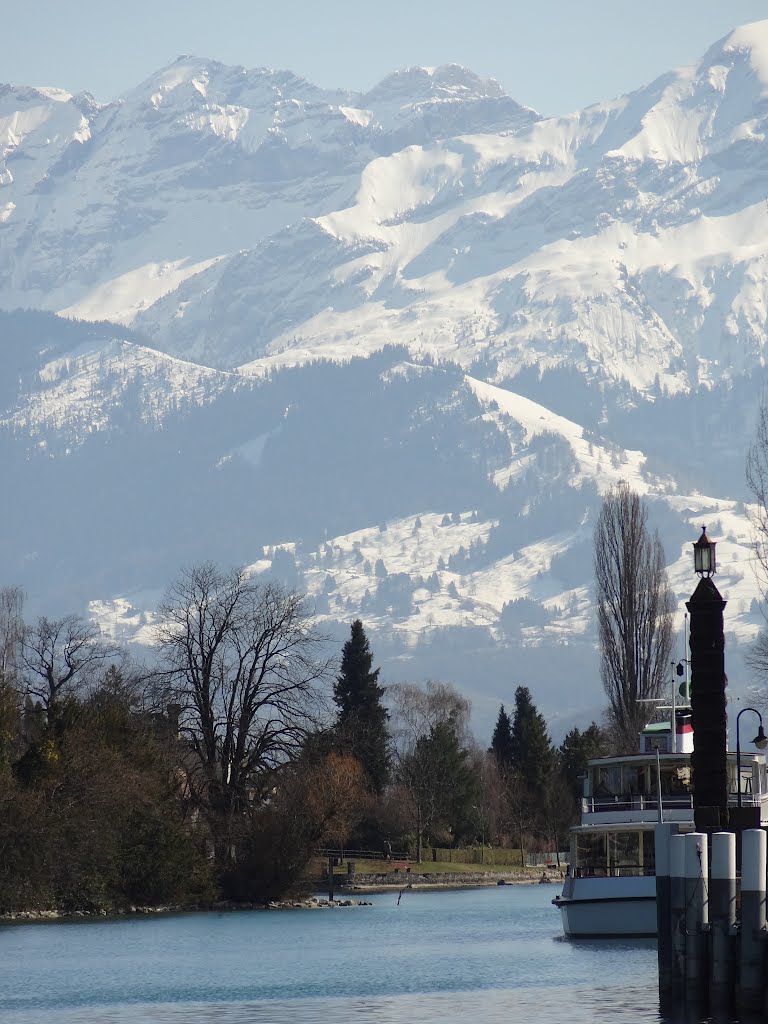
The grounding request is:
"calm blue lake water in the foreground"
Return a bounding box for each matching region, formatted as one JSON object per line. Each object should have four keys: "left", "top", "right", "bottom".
{"left": 0, "top": 885, "right": 708, "bottom": 1024}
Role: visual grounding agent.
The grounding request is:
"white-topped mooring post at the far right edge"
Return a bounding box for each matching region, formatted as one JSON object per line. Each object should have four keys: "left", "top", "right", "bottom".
{"left": 738, "top": 828, "right": 766, "bottom": 1011}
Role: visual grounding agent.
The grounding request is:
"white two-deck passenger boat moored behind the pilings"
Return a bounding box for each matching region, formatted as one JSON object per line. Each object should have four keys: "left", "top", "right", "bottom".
{"left": 552, "top": 715, "right": 768, "bottom": 938}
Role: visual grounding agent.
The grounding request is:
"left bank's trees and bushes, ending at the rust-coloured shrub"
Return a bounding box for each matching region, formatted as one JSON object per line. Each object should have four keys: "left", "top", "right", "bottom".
{"left": 0, "top": 565, "right": 368, "bottom": 911}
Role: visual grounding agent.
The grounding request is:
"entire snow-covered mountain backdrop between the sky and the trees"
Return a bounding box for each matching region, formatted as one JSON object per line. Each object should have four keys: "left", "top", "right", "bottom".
{"left": 0, "top": 22, "right": 768, "bottom": 737}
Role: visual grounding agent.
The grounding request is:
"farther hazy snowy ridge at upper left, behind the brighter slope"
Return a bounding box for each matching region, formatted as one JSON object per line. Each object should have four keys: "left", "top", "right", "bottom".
{"left": 0, "top": 57, "right": 536, "bottom": 331}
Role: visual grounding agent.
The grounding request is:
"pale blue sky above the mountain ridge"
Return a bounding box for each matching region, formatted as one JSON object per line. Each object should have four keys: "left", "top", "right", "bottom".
{"left": 6, "top": 0, "right": 768, "bottom": 114}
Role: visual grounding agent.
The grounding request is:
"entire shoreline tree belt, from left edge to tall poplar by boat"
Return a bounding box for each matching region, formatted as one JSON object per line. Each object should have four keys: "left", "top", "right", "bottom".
{"left": 0, "top": 485, "right": 671, "bottom": 913}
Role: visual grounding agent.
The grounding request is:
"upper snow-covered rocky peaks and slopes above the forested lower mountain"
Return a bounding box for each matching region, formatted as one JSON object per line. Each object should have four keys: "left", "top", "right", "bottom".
{"left": 0, "top": 22, "right": 768, "bottom": 390}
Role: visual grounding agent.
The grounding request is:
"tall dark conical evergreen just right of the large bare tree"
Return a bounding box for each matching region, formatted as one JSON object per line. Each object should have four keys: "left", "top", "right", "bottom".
{"left": 334, "top": 618, "right": 389, "bottom": 794}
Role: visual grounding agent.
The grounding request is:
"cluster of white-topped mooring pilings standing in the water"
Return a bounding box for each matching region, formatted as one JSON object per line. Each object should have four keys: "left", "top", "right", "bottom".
{"left": 655, "top": 823, "right": 768, "bottom": 1020}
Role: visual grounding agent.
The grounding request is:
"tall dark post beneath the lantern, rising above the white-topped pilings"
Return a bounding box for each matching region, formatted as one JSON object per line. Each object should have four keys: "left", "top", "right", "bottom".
{"left": 686, "top": 577, "right": 728, "bottom": 833}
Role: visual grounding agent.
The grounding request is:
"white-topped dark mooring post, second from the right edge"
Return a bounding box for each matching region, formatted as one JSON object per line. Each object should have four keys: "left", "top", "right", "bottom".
{"left": 710, "top": 831, "right": 736, "bottom": 1010}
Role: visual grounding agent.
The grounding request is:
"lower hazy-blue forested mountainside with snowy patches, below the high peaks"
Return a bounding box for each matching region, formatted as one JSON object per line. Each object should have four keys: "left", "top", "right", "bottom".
{"left": 0, "top": 314, "right": 760, "bottom": 730}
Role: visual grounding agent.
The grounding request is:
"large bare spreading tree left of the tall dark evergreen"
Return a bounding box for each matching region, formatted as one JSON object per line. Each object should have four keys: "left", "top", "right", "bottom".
{"left": 156, "top": 563, "right": 331, "bottom": 866}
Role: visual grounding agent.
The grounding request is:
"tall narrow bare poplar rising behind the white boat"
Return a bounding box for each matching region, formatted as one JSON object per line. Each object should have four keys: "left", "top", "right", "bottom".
{"left": 595, "top": 483, "right": 674, "bottom": 751}
